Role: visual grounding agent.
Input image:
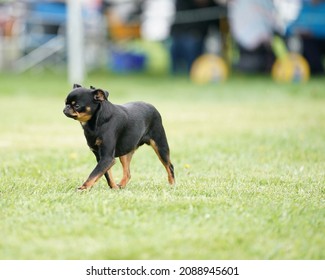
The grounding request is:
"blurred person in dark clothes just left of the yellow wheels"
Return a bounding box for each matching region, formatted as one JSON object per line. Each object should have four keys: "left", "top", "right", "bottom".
{"left": 170, "top": 0, "right": 219, "bottom": 74}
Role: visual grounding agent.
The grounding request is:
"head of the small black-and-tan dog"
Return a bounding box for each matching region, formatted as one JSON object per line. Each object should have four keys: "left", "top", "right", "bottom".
{"left": 63, "top": 84, "right": 108, "bottom": 122}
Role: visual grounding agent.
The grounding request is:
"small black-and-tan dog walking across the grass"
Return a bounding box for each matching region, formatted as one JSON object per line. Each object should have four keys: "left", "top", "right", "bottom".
{"left": 63, "top": 84, "right": 175, "bottom": 190}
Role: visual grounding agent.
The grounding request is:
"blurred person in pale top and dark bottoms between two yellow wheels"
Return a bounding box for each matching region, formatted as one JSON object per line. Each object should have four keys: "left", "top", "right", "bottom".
{"left": 228, "top": 0, "right": 279, "bottom": 72}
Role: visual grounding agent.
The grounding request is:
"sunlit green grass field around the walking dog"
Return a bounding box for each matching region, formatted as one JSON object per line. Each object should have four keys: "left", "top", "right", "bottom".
{"left": 0, "top": 73, "right": 325, "bottom": 259}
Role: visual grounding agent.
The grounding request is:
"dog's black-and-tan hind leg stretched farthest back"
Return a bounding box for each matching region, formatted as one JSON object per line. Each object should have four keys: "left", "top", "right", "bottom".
{"left": 149, "top": 137, "right": 175, "bottom": 185}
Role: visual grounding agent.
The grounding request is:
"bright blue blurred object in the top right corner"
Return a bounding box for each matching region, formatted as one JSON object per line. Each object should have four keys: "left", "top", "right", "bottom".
{"left": 286, "top": 1, "right": 325, "bottom": 38}
